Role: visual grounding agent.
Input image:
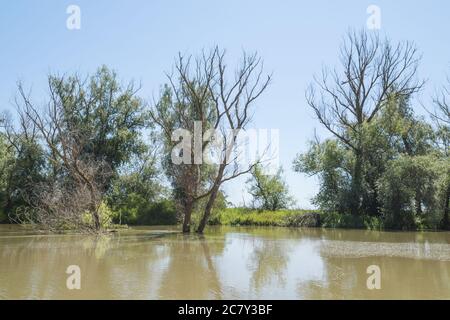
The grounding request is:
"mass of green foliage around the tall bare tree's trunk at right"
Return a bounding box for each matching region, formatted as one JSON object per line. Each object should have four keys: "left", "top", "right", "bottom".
{"left": 294, "top": 90, "right": 449, "bottom": 229}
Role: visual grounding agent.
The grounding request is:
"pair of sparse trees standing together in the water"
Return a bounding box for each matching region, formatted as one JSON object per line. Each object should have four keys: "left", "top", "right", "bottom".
{"left": 151, "top": 47, "right": 270, "bottom": 233}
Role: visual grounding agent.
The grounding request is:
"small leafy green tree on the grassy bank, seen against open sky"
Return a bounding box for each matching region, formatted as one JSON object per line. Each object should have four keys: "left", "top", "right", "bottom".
{"left": 247, "top": 165, "right": 294, "bottom": 211}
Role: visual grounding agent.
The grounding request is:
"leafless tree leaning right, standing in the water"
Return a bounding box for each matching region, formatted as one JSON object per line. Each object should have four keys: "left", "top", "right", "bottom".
{"left": 197, "top": 48, "right": 271, "bottom": 233}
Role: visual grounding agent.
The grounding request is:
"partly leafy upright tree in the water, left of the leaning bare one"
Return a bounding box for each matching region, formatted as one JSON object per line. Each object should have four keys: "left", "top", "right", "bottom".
{"left": 150, "top": 51, "right": 215, "bottom": 233}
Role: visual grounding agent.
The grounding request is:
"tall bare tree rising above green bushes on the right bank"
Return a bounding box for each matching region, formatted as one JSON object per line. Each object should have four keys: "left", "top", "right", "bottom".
{"left": 306, "top": 31, "right": 423, "bottom": 214}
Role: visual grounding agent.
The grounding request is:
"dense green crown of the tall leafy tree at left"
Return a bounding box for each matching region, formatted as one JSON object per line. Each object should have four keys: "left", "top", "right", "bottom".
{"left": 49, "top": 66, "right": 148, "bottom": 170}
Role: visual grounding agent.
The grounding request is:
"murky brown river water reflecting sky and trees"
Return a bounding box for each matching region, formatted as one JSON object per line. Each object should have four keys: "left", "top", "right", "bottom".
{"left": 0, "top": 225, "right": 450, "bottom": 299}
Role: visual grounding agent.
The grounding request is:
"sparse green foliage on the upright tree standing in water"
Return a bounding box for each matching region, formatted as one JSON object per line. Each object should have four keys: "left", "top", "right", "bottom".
{"left": 152, "top": 85, "right": 216, "bottom": 200}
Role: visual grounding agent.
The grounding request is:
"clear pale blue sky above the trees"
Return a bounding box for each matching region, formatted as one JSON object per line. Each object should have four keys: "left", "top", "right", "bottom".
{"left": 0, "top": 0, "right": 450, "bottom": 207}
